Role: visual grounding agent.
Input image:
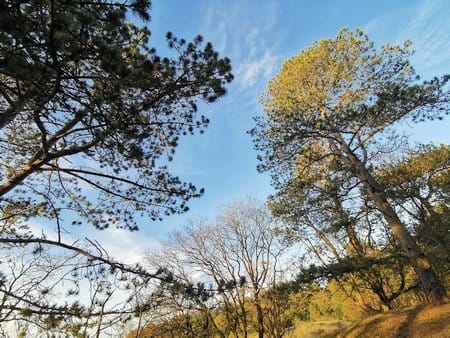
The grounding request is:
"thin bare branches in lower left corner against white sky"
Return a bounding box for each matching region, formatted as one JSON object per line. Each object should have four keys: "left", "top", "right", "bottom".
{"left": 0, "top": 238, "right": 175, "bottom": 337}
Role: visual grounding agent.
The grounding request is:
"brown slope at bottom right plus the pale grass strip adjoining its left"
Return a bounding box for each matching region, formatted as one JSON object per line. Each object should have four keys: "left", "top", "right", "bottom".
{"left": 286, "top": 304, "right": 450, "bottom": 338}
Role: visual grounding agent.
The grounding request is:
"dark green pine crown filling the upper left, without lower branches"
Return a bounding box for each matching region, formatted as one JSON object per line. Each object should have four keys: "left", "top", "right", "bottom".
{"left": 0, "top": 0, "right": 232, "bottom": 229}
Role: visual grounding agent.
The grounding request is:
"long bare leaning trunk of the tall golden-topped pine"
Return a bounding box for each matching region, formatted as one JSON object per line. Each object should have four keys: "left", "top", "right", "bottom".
{"left": 340, "top": 142, "right": 447, "bottom": 304}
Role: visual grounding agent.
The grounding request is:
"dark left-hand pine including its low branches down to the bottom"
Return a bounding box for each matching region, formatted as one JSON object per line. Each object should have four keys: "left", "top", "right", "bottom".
{"left": 0, "top": 0, "right": 233, "bottom": 335}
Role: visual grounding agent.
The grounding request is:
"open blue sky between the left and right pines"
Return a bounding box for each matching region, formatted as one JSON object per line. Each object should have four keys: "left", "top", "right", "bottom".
{"left": 44, "top": 0, "right": 450, "bottom": 261}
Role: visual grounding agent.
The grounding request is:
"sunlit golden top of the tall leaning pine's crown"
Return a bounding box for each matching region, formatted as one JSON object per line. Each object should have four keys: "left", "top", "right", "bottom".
{"left": 263, "top": 29, "right": 412, "bottom": 122}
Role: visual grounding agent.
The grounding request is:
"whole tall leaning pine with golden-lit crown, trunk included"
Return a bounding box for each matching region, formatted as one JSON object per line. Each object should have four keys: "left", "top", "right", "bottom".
{"left": 251, "top": 29, "right": 450, "bottom": 301}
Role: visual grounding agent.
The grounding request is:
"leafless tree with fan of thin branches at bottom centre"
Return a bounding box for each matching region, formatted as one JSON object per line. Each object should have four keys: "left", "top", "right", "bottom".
{"left": 142, "top": 200, "right": 287, "bottom": 337}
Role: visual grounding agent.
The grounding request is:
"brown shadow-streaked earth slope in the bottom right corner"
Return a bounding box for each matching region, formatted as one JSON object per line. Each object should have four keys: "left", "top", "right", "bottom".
{"left": 337, "top": 304, "right": 450, "bottom": 338}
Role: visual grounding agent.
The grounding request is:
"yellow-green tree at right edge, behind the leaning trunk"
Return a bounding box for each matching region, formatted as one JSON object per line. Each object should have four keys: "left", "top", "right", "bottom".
{"left": 377, "top": 144, "right": 450, "bottom": 278}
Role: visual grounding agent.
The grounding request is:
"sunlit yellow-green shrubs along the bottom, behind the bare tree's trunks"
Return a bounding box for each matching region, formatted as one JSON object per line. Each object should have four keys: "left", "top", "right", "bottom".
{"left": 126, "top": 276, "right": 450, "bottom": 338}
